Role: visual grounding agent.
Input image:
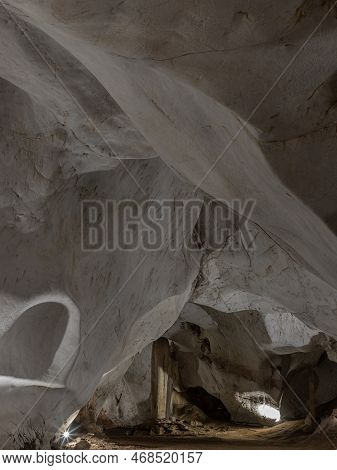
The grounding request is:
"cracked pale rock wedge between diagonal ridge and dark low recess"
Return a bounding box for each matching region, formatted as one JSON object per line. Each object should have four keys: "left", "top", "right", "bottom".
{"left": 192, "top": 218, "right": 337, "bottom": 337}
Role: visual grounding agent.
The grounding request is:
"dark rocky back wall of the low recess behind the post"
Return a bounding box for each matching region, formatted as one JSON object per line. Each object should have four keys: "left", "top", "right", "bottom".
{"left": 87, "top": 303, "right": 337, "bottom": 426}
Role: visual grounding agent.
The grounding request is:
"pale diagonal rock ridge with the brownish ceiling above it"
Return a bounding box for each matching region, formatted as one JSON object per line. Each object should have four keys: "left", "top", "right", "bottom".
{"left": 4, "top": 0, "right": 337, "bottom": 286}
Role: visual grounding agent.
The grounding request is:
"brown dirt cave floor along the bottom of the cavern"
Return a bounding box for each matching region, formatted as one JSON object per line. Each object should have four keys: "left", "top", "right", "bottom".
{"left": 66, "top": 421, "right": 337, "bottom": 450}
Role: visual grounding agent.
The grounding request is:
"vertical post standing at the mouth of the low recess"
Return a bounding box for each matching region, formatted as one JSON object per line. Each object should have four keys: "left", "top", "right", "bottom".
{"left": 151, "top": 338, "right": 172, "bottom": 420}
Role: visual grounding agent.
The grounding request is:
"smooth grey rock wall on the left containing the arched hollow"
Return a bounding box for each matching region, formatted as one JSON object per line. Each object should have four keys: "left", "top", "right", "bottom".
{"left": 0, "top": 151, "right": 198, "bottom": 447}
